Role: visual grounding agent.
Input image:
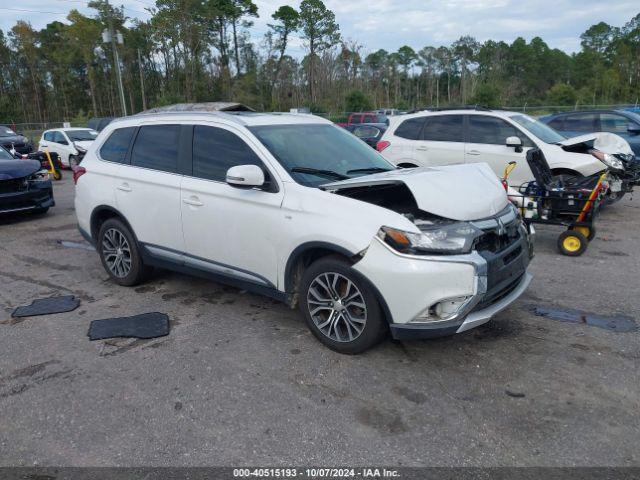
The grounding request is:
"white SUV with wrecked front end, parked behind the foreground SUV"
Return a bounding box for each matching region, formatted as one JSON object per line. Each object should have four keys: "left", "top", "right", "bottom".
{"left": 378, "top": 109, "right": 605, "bottom": 187}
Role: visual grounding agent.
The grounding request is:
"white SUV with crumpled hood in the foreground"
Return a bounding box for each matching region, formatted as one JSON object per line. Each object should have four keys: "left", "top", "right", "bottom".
{"left": 74, "top": 112, "right": 532, "bottom": 353}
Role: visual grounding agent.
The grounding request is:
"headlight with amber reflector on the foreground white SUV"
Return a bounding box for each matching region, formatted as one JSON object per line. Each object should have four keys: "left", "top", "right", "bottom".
{"left": 378, "top": 222, "right": 483, "bottom": 255}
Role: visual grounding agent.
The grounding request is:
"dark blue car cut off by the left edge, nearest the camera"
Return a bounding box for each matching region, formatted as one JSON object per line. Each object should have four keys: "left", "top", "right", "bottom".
{"left": 0, "top": 147, "right": 55, "bottom": 214}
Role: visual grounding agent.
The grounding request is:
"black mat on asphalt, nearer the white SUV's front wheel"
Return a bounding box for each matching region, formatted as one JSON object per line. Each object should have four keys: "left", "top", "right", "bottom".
{"left": 87, "top": 312, "right": 170, "bottom": 340}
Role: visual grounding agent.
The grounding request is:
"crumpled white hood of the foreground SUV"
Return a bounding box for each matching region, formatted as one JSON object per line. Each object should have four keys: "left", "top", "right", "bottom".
{"left": 320, "top": 163, "right": 508, "bottom": 221}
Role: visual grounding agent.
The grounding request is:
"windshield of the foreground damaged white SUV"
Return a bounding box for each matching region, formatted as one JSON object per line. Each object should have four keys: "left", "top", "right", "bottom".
{"left": 249, "top": 124, "right": 395, "bottom": 187}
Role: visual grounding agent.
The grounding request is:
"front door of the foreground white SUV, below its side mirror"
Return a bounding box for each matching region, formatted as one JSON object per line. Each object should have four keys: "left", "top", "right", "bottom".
{"left": 180, "top": 124, "right": 284, "bottom": 288}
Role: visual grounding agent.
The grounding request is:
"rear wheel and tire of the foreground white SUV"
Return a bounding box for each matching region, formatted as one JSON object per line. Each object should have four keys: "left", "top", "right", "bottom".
{"left": 97, "top": 218, "right": 149, "bottom": 287}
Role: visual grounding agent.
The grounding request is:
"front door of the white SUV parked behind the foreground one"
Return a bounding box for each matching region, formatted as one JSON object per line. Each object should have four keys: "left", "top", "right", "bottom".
{"left": 465, "top": 115, "right": 534, "bottom": 185}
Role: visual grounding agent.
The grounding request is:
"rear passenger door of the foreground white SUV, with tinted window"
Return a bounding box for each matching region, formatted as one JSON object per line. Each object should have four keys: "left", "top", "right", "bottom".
{"left": 115, "top": 124, "right": 186, "bottom": 256}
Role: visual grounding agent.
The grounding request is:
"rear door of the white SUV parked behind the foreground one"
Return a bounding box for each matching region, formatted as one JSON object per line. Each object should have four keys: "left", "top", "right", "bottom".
{"left": 413, "top": 114, "right": 464, "bottom": 166}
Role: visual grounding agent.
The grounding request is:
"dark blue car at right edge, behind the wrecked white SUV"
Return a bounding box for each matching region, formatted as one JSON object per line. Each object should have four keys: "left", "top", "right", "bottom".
{"left": 540, "top": 110, "right": 640, "bottom": 157}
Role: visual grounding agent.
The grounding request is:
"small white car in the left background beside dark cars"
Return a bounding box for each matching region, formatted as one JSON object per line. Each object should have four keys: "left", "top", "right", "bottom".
{"left": 38, "top": 128, "right": 98, "bottom": 168}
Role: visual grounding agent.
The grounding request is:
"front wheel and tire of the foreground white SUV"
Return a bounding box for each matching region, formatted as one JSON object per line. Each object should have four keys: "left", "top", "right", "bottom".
{"left": 300, "top": 257, "right": 387, "bottom": 354}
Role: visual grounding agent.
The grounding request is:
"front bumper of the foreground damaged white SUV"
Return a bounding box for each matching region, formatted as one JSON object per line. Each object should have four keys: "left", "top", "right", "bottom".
{"left": 353, "top": 226, "right": 532, "bottom": 340}
